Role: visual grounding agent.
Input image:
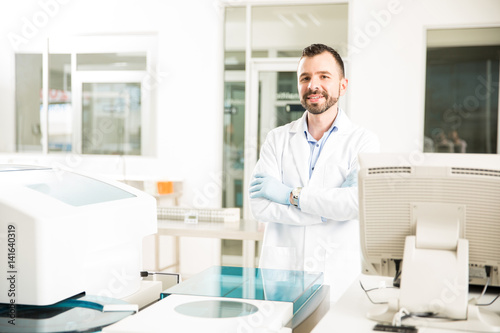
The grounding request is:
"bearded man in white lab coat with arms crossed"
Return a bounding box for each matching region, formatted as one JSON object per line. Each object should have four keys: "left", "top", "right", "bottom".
{"left": 249, "top": 44, "right": 379, "bottom": 301}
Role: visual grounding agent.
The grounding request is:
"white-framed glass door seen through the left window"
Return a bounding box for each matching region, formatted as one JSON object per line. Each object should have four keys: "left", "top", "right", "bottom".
{"left": 74, "top": 71, "right": 149, "bottom": 156}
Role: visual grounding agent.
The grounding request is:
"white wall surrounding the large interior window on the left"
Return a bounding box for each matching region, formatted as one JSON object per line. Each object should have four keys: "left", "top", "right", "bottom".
{"left": 0, "top": 0, "right": 223, "bottom": 207}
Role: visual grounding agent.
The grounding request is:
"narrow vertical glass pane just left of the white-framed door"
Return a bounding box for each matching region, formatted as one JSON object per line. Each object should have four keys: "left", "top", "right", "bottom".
{"left": 48, "top": 54, "right": 73, "bottom": 151}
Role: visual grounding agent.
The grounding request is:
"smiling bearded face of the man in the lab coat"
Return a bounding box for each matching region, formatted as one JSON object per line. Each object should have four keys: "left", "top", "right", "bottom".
{"left": 297, "top": 51, "right": 347, "bottom": 114}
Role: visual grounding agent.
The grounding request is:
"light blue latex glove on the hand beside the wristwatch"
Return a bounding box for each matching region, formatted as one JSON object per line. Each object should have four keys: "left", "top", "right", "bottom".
{"left": 249, "top": 173, "right": 292, "bottom": 205}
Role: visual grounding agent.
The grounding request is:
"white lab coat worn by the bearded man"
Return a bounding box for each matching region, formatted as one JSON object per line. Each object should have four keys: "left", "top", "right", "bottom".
{"left": 250, "top": 110, "right": 379, "bottom": 302}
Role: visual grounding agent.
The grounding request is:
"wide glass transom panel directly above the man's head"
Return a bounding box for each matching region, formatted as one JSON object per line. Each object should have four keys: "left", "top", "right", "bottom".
{"left": 252, "top": 4, "right": 347, "bottom": 58}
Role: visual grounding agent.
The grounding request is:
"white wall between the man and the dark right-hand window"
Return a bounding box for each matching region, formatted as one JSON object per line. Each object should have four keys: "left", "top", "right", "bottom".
{"left": 348, "top": 0, "right": 500, "bottom": 152}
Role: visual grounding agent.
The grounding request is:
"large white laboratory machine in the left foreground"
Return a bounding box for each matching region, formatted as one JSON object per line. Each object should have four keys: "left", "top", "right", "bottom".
{"left": 0, "top": 165, "right": 157, "bottom": 330}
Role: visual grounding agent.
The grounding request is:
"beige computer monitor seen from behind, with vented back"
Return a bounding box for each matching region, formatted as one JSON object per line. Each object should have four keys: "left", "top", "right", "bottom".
{"left": 358, "top": 152, "right": 500, "bottom": 326}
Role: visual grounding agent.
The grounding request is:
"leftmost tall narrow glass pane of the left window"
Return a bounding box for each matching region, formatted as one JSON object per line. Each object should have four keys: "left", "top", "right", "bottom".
{"left": 16, "top": 54, "right": 42, "bottom": 152}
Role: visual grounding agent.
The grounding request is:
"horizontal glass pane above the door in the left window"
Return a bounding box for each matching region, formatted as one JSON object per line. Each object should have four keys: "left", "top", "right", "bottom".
{"left": 76, "top": 52, "right": 147, "bottom": 71}
